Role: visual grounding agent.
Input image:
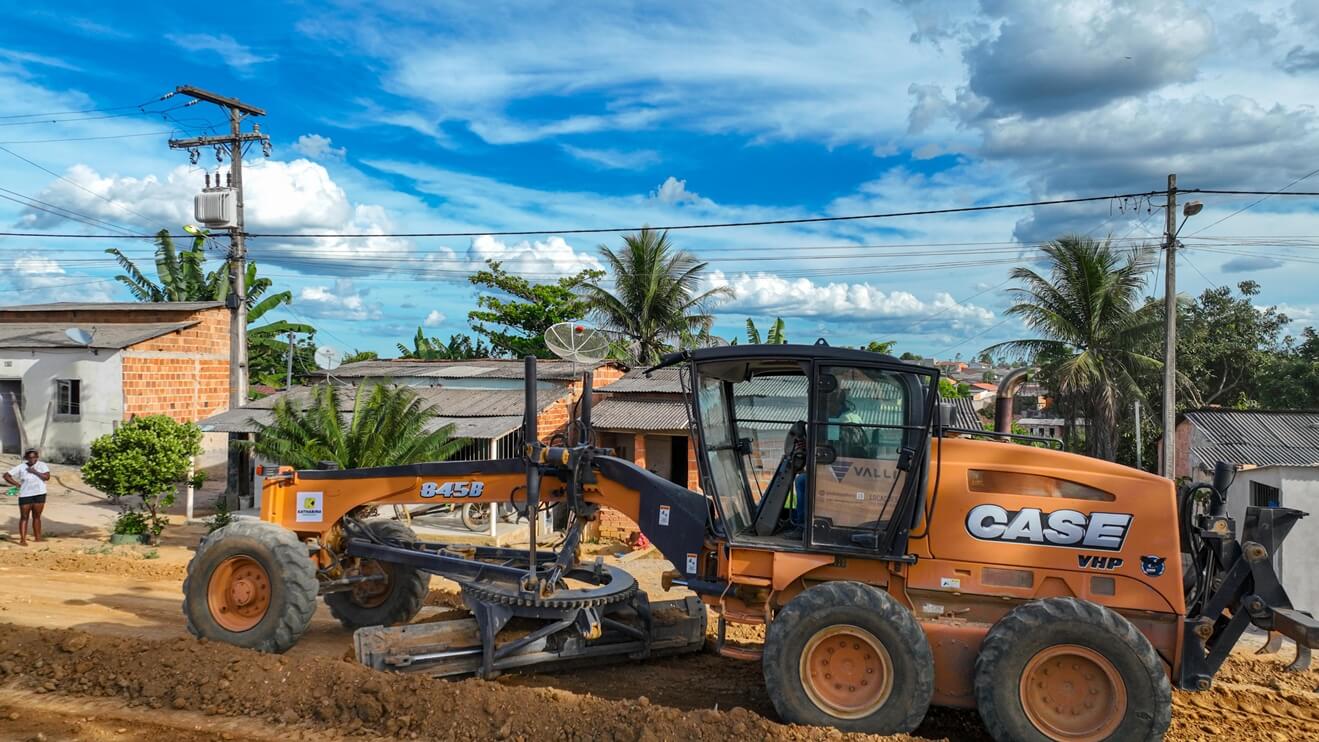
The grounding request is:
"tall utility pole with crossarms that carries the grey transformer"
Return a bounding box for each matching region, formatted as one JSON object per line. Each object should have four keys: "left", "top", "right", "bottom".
{"left": 169, "top": 86, "right": 270, "bottom": 506}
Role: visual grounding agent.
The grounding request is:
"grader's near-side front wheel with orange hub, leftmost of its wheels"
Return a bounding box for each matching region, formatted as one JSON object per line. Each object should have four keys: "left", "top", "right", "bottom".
{"left": 183, "top": 521, "right": 317, "bottom": 652}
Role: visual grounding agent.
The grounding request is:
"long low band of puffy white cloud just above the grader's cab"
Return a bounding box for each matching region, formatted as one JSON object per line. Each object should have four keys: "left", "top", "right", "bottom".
{"left": 710, "top": 271, "right": 995, "bottom": 329}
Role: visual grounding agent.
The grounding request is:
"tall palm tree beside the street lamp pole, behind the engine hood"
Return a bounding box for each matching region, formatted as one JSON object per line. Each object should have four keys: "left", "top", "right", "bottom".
{"left": 984, "top": 235, "right": 1162, "bottom": 461}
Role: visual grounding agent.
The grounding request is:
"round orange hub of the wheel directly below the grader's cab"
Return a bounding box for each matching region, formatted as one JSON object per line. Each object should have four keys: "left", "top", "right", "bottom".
{"left": 801, "top": 625, "right": 893, "bottom": 718}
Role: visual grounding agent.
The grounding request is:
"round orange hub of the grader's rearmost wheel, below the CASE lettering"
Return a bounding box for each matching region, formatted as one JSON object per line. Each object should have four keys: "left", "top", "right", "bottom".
{"left": 1021, "top": 644, "right": 1126, "bottom": 741}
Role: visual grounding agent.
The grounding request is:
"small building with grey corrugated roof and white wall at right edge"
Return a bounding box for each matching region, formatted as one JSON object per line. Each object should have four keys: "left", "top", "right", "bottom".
{"left": 1175, "top": 409, "right": 1319, "bottom": 610}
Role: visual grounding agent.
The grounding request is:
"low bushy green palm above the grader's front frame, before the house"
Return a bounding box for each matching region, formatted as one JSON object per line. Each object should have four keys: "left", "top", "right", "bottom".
{"left": 253, "top": 384, "right": 467, "bottom": 469}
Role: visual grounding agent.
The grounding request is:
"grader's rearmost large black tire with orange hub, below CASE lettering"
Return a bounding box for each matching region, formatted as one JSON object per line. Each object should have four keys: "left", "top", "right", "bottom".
{"left": 975, "top": 598, "right": 1173, "bottom": 742}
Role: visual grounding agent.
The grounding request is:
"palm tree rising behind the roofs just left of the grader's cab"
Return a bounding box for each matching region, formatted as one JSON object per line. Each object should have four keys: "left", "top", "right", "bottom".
{"left": 584, "top": 228, "right": 733, "bottom": 362}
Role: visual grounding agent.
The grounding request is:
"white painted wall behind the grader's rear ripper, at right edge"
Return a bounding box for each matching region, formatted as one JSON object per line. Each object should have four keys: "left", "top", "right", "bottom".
{"left": 1228, "top": 467, "right": 1319, "bottom": 613}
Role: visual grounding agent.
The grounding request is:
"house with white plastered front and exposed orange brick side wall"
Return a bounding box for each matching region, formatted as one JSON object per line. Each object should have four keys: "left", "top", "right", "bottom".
{"left": 0, "top": 302, "right": 230, "bottom": 467}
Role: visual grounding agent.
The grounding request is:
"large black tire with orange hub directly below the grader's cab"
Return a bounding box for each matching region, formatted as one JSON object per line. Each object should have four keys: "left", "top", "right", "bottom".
{"left": 762, "top": 581, "right": 934, "bottom": 734}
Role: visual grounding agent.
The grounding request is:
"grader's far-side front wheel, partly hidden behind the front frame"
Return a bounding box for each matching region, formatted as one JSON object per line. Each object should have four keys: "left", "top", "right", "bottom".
{"left": 326, "top": 521, "right": 430, "bottom": 629}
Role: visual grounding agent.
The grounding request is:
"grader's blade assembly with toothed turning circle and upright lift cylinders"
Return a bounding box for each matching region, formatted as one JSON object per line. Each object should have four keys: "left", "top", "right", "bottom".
{"left": 346, "top": 357, "right": 706, "bottom": 679}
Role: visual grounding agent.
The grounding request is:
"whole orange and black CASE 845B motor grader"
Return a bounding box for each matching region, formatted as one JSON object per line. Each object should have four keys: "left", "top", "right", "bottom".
{"left": 183, "top": 344, "right": 1319, "bottom": 739}
